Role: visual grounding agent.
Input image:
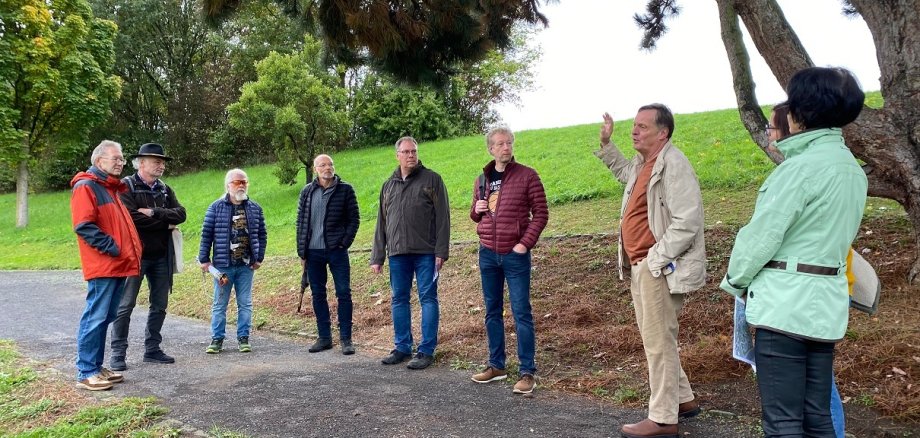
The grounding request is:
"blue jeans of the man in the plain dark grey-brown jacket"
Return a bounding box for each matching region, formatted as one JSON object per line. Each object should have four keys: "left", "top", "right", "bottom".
{"left": 390, "top": 254, "right": 439, "bottom": 356}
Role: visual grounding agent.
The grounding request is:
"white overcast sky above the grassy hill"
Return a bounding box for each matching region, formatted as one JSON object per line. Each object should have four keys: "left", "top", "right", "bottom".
{"left": 499, "top": 0, "right": 879, "bottom": 131}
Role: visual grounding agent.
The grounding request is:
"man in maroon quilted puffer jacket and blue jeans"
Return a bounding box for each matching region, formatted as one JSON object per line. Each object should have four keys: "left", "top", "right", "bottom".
{"left": 470, "top": 127, "right": 549, "bottom": 394}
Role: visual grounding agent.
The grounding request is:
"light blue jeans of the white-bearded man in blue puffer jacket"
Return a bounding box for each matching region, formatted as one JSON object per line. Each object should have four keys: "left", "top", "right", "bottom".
{"left": 211, "top": 265, "right": 255, "bottom": 339}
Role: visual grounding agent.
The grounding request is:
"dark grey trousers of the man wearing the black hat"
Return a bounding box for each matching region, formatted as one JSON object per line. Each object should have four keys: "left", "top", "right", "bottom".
{"left": 112, "top": 257, "right": 170, "bottom": 357}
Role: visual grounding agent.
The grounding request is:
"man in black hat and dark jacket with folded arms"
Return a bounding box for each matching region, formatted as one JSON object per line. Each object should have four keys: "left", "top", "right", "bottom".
{"left": 110, "top": 143, "right": 185, "bottom": 371}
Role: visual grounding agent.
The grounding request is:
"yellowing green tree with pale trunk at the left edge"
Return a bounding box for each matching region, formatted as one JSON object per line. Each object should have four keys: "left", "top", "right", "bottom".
{"left": 0, "top": 0, "right": 121, "bottom": 227}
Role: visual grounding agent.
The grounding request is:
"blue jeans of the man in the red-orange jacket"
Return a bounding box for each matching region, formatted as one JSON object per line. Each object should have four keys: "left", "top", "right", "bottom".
{"left": 77, "top": 277, "right": 125, "bottom": 381}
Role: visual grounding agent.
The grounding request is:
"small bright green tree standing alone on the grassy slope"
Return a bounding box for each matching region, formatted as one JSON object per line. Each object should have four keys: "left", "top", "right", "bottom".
{"left": 227, "top": 37, "right": 350, "bottom": 184}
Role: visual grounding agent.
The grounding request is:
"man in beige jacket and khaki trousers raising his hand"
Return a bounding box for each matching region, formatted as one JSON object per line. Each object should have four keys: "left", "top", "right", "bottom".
{"left": 594, "top": 104, "right": 706, "bottom": 438}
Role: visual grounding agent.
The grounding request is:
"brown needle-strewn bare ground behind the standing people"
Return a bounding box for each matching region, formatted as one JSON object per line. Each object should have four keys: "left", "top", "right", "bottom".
{"left": 263, "top": 217, "right": 920, "bottom": 437}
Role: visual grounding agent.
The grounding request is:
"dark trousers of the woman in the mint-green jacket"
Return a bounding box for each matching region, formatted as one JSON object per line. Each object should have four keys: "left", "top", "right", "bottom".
{"left": 754, "top": 329, "right": 836, "bottom": 438}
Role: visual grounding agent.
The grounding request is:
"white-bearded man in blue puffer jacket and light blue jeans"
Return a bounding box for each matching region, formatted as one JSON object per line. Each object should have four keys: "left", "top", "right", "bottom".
{"left": 198, "top": 169, "right": 268, "bottom": 354}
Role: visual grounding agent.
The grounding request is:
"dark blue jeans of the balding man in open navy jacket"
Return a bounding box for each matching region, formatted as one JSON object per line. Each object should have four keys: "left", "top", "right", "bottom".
{"left": 307, "top": 248, "right": 353, "bottom": 339}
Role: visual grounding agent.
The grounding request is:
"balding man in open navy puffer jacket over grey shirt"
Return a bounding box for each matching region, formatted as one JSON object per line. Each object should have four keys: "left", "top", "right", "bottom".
{"left": 297, "top": 154, "right": 361, "bottom": 355}
